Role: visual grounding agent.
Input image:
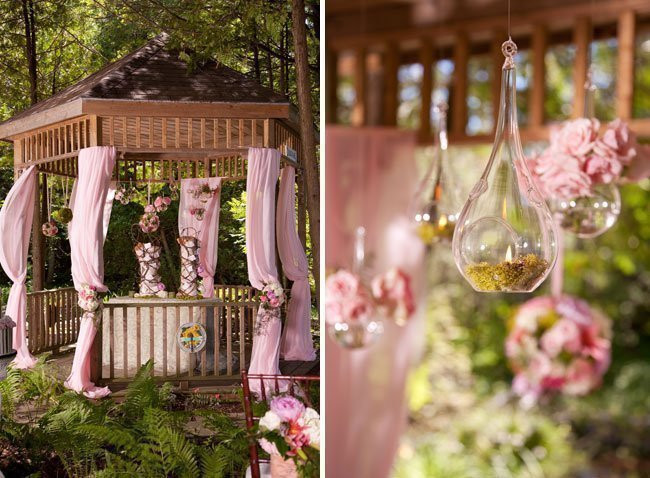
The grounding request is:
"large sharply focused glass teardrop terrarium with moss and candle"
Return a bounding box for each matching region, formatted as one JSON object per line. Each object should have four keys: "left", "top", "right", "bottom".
{"left": 452, "top": 39, "right": 557, "bottom": 292}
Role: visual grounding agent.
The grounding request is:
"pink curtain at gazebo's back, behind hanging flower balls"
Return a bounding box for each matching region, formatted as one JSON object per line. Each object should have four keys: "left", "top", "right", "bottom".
{"left": 178, "top": 178, "right": 221, "bottom": 298}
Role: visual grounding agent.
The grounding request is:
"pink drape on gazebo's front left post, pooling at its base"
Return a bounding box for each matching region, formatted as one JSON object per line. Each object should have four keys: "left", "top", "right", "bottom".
{"left": 65, "top": 146, "right": 115, "bottom": 398}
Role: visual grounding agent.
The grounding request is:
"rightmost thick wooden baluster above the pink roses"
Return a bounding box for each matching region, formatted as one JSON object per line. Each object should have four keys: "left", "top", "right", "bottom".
{"left": 616, "top": 9, "right": 636, "bottom": 120}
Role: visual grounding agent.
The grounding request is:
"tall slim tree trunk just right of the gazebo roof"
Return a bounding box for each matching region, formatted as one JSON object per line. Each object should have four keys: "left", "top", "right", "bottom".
{"left": 291, "top": 0, "right": 320, "bottom": 303}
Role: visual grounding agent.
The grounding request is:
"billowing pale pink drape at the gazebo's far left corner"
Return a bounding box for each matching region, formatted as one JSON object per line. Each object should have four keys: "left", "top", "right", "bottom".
{"left": 0, "top": 166, "right": 38, "bottom": 368}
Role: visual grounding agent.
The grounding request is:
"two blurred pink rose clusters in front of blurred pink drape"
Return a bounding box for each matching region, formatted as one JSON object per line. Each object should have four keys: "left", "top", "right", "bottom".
{"left": 325, "top": 268, "right": 415, "bottom": 325}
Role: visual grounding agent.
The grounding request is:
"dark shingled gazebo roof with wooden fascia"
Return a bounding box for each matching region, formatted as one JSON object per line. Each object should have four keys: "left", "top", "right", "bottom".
{"left": 0, "top": 34, "right": 290, "bottom": 139}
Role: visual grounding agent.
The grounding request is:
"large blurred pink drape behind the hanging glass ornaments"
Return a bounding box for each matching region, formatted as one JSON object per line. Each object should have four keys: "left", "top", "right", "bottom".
{"left": 323, "top": 126, "right": 424, "bottom": 478}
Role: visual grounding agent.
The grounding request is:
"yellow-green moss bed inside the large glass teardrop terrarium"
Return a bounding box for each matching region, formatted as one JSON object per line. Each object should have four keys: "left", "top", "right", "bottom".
{"left": 465, "top": 254, "right": 548, "bottom": 292}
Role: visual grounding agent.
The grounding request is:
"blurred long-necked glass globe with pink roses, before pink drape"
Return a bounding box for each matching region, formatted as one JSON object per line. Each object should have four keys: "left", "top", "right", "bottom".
{"left": 325, "top": 227, "right": 384, "bottom": 349}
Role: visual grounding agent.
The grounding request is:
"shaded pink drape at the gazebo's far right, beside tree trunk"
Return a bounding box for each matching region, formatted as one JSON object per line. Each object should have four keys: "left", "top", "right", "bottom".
{"left": 275, "top": 166, "right": 316, "bottom": 361}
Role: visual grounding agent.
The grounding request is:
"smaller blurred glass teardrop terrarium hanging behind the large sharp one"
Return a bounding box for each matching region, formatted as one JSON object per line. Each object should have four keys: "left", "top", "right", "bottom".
{"left": 409, "top": 103, "right": 462, "bottom": 245}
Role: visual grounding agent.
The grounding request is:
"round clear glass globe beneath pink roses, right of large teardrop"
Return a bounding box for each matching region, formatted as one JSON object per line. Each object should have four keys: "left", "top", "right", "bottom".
{"left": 550, "top": 183, "right": 621, "bottom": 239}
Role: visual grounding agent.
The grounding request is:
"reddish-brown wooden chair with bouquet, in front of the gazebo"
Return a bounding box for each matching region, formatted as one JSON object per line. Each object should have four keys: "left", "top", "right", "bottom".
{"left": 241, "top": 370, "right": 320, "bottom": 478}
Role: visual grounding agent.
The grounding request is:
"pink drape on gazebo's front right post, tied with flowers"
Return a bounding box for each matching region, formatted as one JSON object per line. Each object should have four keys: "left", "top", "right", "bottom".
{"left": 246, "top": 148, "right": 282, "bottom": 393}
